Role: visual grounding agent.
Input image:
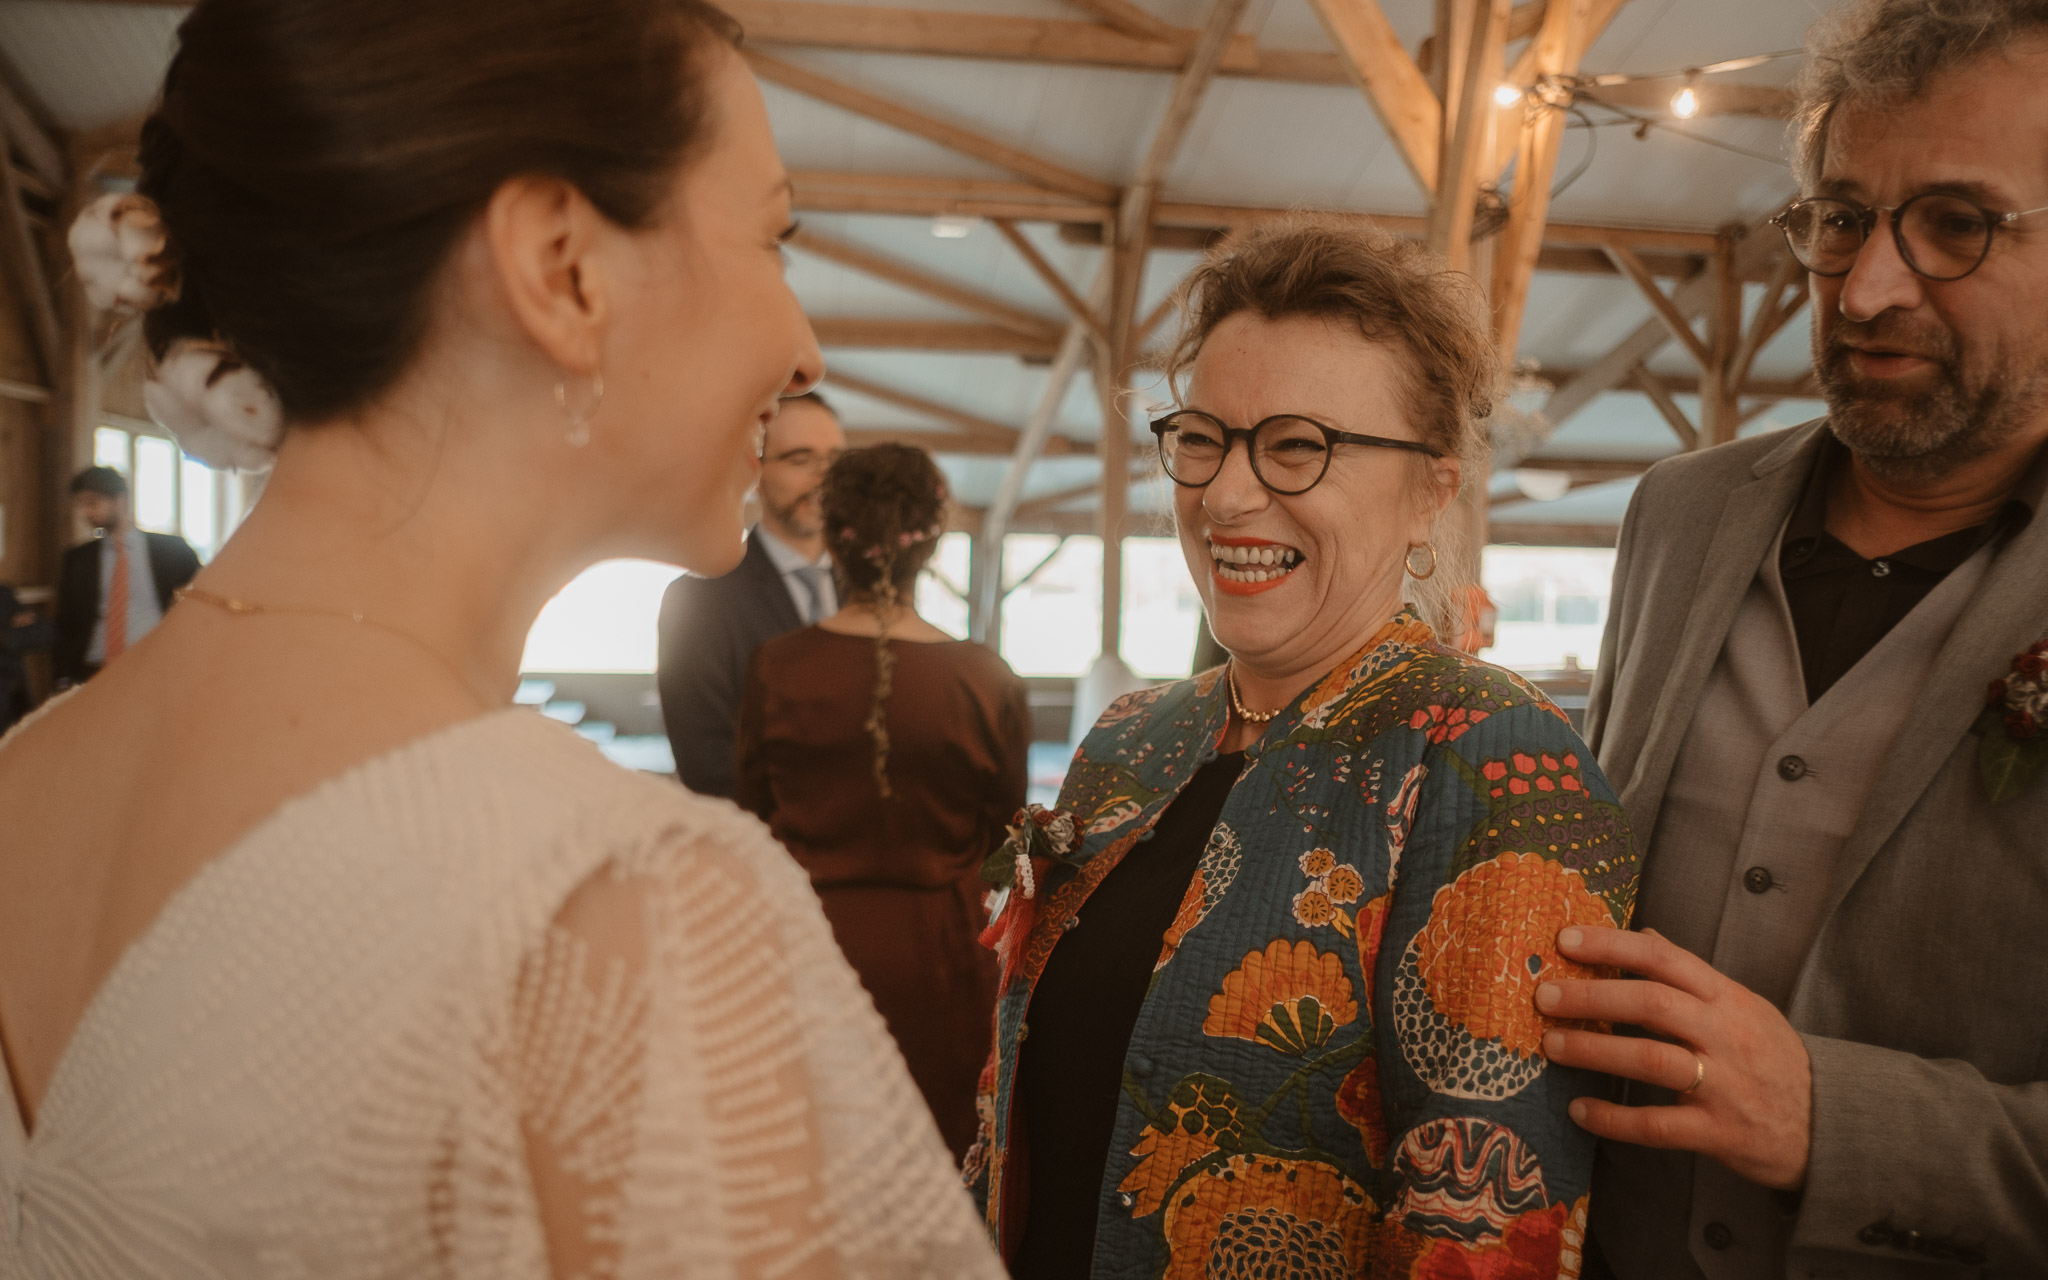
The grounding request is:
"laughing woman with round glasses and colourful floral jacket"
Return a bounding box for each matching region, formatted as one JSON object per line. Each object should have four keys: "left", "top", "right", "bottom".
{"left": 969, "top": 219, "right": 1636, "bottom": 1280}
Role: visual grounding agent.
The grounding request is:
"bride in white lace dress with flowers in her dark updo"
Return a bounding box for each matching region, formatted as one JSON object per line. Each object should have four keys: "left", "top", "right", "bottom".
{"left": 0, "top": 0, "right": 999, "bottom": 1280}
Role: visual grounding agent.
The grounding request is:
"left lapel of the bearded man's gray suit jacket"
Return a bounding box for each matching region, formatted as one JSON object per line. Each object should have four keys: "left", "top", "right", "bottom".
{"left": 1622, "top": 422, "right": 1827, "bottom": 842}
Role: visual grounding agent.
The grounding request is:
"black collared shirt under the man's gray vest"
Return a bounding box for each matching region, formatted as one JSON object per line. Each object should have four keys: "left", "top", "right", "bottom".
{"left": 1778, "top": 434, "right": 2048, "bottom": 705}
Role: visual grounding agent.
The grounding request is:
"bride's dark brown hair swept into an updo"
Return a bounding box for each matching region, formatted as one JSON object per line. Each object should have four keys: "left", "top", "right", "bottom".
{"left": 139, "top": 0, "right": 737, "bottom": 422}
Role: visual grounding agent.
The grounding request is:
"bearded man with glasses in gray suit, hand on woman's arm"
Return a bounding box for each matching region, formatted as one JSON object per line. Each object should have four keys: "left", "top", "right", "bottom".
{"left": 1538, "top": 0, "right": 2048, "bottom": 1280}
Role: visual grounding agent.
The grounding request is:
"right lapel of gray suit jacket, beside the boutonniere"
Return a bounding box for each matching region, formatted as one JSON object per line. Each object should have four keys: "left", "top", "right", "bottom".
{"left": 1823, "top": 499, "right": 2048, "bottom": 920}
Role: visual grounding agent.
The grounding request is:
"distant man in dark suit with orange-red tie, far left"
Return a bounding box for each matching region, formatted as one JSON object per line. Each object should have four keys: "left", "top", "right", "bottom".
{"left": 51, "top": 467, "right": 199, "bottom": 688}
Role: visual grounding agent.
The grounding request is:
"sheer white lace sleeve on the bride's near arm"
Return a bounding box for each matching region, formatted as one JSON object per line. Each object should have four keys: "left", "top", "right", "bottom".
{"left": 512, "top": 815, "right": 1001, "bottom": 1280}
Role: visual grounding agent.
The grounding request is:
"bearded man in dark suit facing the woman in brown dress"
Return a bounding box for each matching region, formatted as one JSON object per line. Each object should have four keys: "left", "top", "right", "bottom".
{"left": 655, "top": 391, "right": 846, "bottom": 797}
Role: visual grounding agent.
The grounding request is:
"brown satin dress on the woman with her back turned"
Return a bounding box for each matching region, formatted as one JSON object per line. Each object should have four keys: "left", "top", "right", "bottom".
{"left": 733, "top": 627, "right": 1030, "bottom": 1157}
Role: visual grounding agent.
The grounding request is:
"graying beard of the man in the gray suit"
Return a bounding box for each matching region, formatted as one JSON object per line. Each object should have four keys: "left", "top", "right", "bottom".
{"left": 1812, "top": 313, "right": 2044, "bottom": 483}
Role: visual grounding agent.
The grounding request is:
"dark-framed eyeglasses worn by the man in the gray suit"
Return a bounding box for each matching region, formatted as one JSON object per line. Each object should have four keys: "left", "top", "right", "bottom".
{"left": 1772, "top": 190, "right": 2048, "bottom": 281}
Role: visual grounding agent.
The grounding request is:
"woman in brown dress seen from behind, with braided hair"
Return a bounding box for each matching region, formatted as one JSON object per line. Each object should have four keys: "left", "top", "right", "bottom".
{"left": 735, "top": 444, "right": 1030, "bottom": 1157}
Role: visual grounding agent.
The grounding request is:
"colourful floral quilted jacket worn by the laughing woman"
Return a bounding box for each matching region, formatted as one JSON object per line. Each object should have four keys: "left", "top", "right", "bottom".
{"left": 967, "top": 612, "right": 1636, "bottom": 1280}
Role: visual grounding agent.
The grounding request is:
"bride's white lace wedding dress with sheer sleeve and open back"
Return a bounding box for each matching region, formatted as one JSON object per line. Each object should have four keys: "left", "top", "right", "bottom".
{"left": 0, "top": 711, "right": 1001, "bottom": 1280}
